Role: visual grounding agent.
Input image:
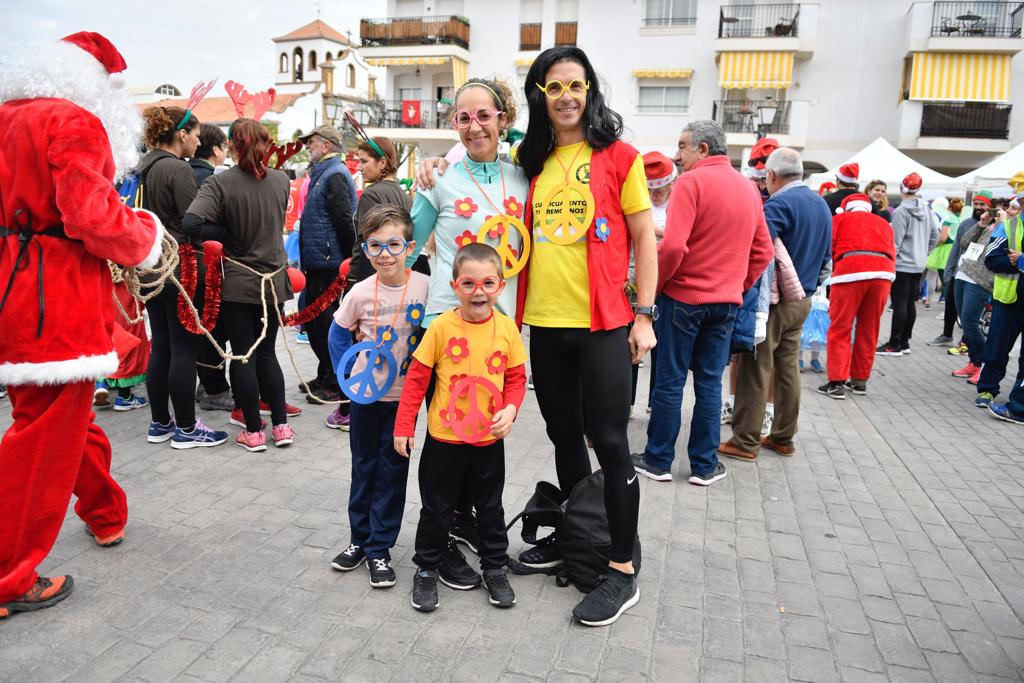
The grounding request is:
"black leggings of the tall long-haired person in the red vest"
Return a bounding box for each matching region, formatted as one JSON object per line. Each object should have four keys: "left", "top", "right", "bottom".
{"left": 529, "top": 326, "right": 640, "bottom": 562}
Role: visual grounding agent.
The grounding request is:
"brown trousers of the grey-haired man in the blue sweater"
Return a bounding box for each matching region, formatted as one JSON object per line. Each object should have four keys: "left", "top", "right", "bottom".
{"left": 732, "top": 297, "right": 811, "bottom": 453}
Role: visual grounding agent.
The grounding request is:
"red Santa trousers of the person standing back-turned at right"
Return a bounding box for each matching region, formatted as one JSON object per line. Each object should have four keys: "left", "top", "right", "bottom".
{"left": 827, "top": 280, "right": 892, "bottom": 382}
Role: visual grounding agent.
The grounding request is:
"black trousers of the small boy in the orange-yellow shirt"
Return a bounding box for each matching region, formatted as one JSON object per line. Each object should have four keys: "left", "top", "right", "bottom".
{"left": 413, "top": 434, "right": 509, "bottom": 569}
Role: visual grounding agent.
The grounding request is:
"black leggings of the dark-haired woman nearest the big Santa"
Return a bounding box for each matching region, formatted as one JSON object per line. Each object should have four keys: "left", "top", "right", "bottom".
{"left": 145, "top": 285, "right": 203, "bottom": 430}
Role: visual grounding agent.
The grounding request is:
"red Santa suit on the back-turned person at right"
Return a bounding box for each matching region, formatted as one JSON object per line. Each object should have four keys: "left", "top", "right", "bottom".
{"left": 826, "top": 194, "right": 896, "bottom": 382}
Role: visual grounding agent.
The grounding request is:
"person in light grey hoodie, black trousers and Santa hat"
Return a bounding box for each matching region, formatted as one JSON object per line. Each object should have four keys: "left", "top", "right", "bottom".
{"left": 878, "top": 173, "right": 939, "bottom": 355}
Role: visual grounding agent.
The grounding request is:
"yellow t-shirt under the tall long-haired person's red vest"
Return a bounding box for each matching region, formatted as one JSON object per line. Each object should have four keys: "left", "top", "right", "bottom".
{"left": 523, "top": 141, "right": 650, "bottom": 329}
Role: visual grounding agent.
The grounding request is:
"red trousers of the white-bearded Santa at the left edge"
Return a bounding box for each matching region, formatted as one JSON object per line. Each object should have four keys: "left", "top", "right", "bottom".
{"left": 0, "top": 382, "right": 128, "bottom": 602}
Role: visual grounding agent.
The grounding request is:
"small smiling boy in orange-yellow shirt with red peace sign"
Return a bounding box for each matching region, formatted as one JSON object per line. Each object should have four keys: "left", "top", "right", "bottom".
{"left": 394, "top": 243, "right": 526, "bottom": 611}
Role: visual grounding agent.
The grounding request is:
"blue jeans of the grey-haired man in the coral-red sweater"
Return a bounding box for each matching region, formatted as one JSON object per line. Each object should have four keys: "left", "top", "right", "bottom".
{"left": 644, "top": 294, "right": 739, "bottom": 476}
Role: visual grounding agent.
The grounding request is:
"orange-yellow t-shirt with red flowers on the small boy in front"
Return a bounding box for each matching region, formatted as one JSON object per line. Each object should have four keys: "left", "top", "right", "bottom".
{"left": 413, "top": 309, "right": 526, "bottom": 444}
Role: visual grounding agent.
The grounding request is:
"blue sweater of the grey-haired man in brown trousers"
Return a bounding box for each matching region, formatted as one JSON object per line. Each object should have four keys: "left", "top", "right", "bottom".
{"left": 765, "top": 183, "right": 833, "bottom": 296}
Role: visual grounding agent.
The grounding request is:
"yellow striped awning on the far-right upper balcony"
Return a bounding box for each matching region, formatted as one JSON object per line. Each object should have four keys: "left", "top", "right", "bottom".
{"left": 910, "top": 52, "right": 1013, "bottom": 102}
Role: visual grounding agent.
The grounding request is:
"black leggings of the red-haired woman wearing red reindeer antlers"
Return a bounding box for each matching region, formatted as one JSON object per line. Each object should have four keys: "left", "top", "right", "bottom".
{"left": 218, "top": 301, "right": 288, "bottom": 432}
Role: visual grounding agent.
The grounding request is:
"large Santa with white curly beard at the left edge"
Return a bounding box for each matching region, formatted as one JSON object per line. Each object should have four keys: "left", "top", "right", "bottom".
{"left": 0, "top": 33, "right": 163, "bottom": 617}
